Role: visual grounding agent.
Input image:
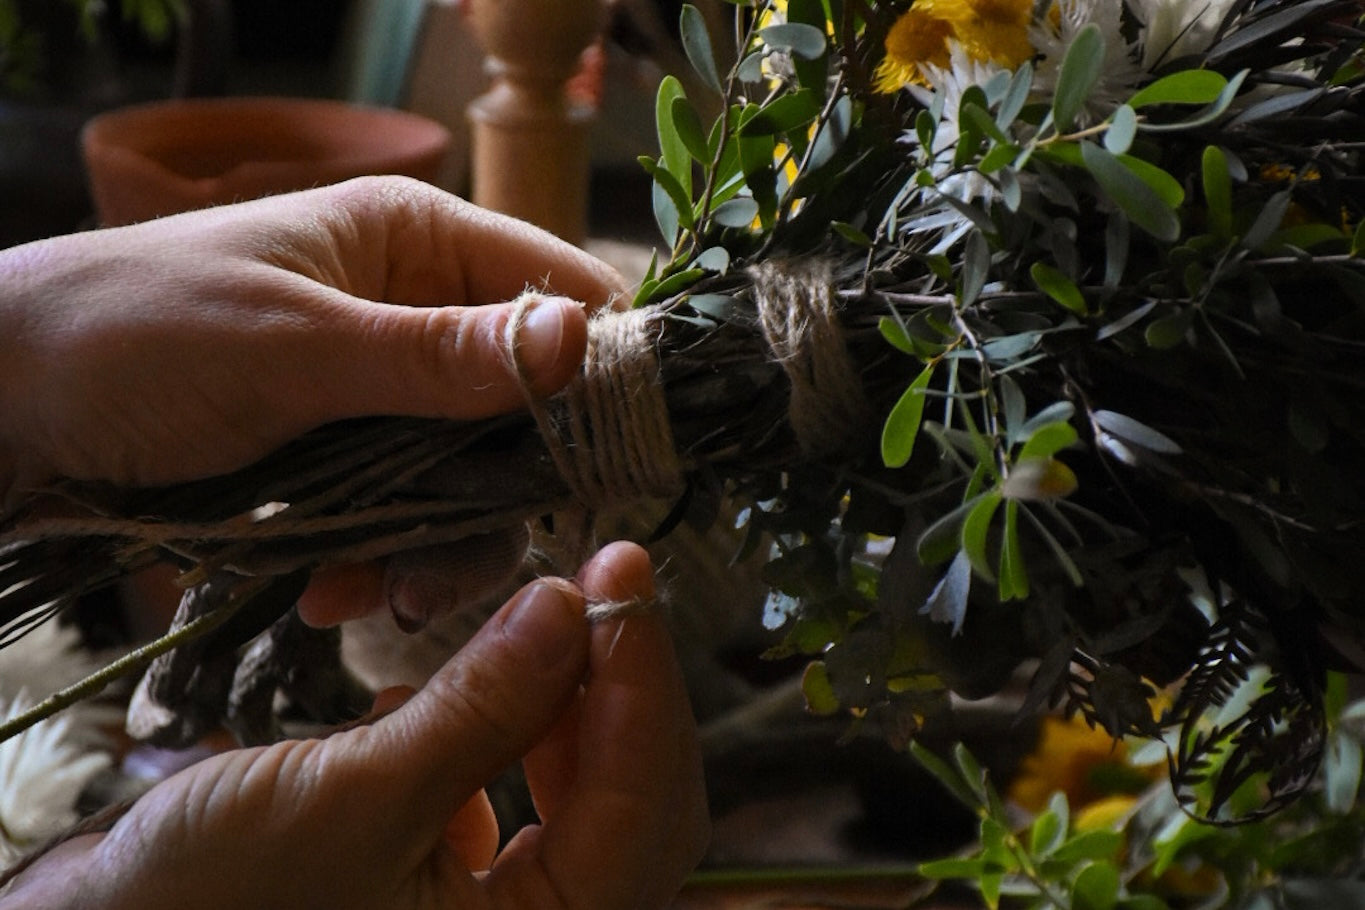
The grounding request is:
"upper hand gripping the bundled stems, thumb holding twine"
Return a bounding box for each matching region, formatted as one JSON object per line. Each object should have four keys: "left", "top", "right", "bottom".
{"left": 0, "top": 177, "right": 622, "bottom": 499}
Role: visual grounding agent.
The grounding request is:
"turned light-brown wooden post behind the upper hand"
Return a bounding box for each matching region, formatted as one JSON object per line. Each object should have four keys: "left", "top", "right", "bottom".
{"left": 465, "top": 0, "right": 606, "bottom": 244}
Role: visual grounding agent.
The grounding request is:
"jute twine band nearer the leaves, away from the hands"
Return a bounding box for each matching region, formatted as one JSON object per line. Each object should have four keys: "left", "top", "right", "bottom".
{"left": 748, "top": 259, "right": 871, "bottom": 457}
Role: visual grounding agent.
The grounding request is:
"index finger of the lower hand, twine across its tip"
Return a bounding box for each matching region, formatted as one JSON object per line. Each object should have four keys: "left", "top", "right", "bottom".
{"left": 489, "top": 544, "right": 710, "bottom": 910}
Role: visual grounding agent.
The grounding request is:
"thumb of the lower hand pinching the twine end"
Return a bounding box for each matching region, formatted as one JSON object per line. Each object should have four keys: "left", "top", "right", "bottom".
{"left": 337, "top": 578, "right": 590, "bottom": 842}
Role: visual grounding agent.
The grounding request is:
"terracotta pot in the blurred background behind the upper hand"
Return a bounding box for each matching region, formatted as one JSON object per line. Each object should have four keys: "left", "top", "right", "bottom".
{"left": 82, "top": 97, "right": 450, "bottom": 226}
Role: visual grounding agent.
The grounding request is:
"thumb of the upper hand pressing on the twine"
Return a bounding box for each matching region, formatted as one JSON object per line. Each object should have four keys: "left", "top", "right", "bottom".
{"left": 314, "top": 295, "right": 587, "bottom": 420}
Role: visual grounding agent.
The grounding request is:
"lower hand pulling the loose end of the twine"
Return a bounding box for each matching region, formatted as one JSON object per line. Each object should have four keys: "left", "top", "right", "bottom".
{"left": 8, "top": 544, "right": 708, "bottom": 910}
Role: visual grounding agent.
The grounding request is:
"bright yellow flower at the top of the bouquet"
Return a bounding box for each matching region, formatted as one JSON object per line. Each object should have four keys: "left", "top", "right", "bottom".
{"left": 875, "top": 0, "right": 1033, "bottom": 91}
